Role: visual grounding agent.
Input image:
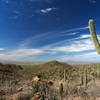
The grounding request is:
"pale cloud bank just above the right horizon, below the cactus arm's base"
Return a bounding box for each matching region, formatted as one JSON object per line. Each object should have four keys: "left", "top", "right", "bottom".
{"left": 56, "top": 52, "right": 100, "bottom": 63}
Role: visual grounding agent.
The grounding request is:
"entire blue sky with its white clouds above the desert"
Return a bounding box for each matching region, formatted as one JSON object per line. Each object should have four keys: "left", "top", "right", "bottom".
{"left": 0, "top": 0, "right": 100, "bottom": 62}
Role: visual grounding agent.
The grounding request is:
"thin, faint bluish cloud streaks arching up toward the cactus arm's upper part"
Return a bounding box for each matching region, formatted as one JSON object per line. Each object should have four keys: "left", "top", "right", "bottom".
{"left": 19, "top": 27, "right": 88, "bottom": 48}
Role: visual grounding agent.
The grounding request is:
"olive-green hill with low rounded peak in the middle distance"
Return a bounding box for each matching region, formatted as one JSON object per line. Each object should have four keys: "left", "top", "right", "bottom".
{"left": 23, "top": 61, "right": 73, "bottom": 78}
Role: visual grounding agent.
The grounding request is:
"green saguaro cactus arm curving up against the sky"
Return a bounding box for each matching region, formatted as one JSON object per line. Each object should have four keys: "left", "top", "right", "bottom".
{"left": 89, "top": 19, "right": 100, "bottom": 54}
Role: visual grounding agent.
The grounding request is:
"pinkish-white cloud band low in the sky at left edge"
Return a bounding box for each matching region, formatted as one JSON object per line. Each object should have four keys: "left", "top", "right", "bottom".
{"left": 0, "top": 49, "right": 44, "bottom": 61}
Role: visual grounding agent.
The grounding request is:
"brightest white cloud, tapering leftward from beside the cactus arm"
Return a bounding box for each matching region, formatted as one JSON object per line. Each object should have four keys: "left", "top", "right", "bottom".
{"left": 49, "top": 39, "right": 94, "bottom": 52}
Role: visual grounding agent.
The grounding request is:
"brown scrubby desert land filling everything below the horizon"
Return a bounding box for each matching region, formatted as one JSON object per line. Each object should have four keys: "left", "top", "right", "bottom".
{"left": 0, "top": 61, "right": 100, "bottom": 100}
